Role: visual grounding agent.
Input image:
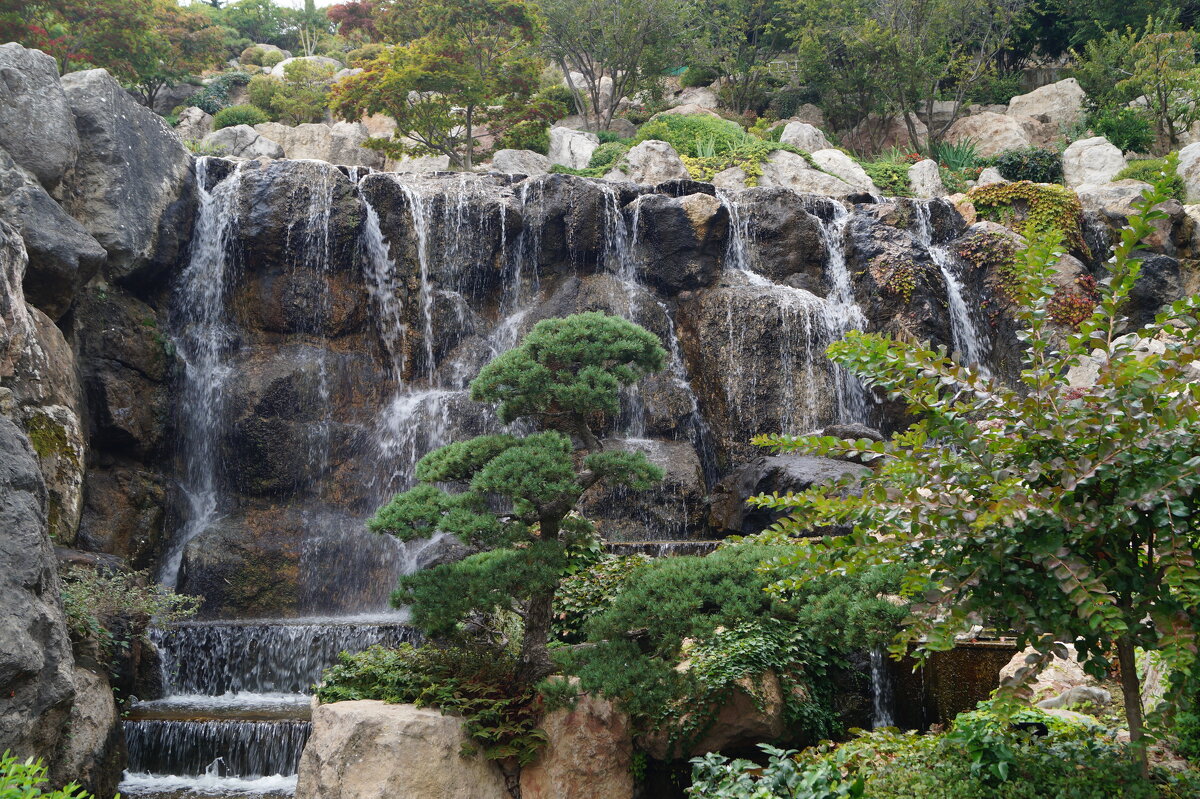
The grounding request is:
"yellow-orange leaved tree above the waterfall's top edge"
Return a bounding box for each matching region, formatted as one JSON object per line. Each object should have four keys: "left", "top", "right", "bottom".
{"left": 332, "top": 0, "right": 539, "bottom": 169}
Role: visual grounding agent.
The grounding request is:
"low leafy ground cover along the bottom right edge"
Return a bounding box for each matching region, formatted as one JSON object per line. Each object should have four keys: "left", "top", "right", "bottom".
{"left": 689, "top": 705, "right": 1196, "bottom": 799}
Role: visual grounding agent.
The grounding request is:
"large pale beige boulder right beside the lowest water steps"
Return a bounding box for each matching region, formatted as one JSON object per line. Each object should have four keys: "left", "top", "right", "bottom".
{"left": 295, "top": 701, "right": 510, "bottom": 799}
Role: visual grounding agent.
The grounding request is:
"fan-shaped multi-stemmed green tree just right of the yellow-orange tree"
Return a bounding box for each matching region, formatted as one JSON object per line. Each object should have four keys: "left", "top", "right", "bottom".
{"left": 541, "top": 0, "right": 696, "bottom": 130}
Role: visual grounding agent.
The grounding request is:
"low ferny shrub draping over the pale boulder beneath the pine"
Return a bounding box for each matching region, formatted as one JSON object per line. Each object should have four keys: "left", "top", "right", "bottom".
{"left": 317, "top": 644, "right": 546, "bottom": 765}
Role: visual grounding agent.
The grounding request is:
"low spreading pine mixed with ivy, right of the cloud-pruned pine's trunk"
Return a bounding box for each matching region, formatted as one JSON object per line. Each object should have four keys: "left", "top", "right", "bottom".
{"left": 560, "top": 543, "right": 905, "bottom": 746}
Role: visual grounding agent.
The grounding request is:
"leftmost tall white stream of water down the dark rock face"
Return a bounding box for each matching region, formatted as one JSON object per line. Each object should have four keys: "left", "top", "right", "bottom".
{"left": 158, "top": 156, "right": 242, "bottom": 588}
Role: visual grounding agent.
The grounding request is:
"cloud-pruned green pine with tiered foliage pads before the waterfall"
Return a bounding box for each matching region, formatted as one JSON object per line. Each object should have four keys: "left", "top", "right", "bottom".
{"left": 370, "top": 312, "right": 666, "bottom": 681}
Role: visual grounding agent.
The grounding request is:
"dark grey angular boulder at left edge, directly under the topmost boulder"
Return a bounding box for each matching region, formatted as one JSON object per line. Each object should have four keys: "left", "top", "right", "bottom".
{"left": 0, "top": 150, "right": 108, "bottom": 320}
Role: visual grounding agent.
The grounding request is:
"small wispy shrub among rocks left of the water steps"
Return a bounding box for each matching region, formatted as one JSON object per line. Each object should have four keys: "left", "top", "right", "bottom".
{"left": 62, "top": 569, "right": 200, "bottom": 660}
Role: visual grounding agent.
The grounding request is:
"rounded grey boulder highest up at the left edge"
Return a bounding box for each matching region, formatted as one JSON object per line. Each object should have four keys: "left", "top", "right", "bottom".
{"left": 0, "top": 42, "right": 79, "bottom": 188}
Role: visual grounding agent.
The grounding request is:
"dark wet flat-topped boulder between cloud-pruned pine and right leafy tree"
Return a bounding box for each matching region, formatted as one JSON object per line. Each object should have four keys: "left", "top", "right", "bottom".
{"left": 708, "top": 455, "right": 870, "bottom": 535}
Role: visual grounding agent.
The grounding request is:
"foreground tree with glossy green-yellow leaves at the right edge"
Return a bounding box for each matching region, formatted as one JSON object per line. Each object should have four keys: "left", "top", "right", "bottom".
{"left": 756, "top": 167, "right": 1200, "bottom": 769}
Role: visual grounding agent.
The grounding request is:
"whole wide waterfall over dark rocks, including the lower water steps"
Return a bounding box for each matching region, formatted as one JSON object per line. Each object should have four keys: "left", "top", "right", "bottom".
{"left": 121, "top": 157, "right": 1003, "bottom": 797}
